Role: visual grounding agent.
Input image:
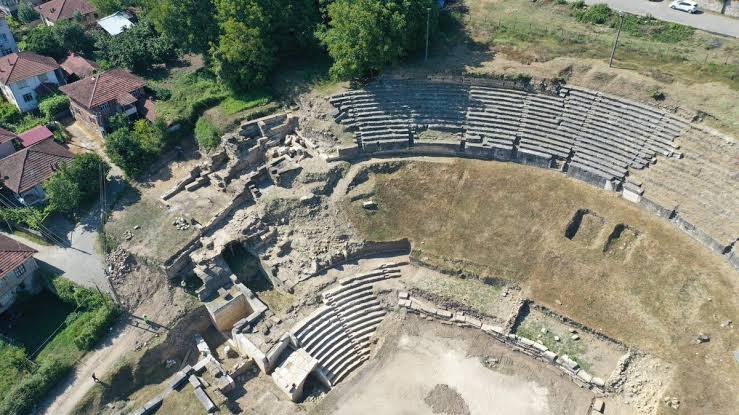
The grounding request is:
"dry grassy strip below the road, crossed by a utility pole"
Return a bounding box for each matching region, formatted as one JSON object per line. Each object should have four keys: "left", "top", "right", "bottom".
{"left": 466, "top": 0, "right": 739, "bottom": 90}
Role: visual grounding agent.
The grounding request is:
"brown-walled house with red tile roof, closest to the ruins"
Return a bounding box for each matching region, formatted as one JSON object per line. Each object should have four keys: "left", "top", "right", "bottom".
{"left": 59, "top": 69, "right": 148, "bottom": 132}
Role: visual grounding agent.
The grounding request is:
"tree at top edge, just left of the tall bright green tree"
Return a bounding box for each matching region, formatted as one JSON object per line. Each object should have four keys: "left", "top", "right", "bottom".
{"left": 147, "top": 0, "right": 218, "bottom": 53}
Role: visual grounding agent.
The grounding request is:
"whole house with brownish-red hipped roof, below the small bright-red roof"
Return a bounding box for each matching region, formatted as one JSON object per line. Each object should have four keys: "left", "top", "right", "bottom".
{"left": 0, "top": 139, "right": 74, "bottom": 206}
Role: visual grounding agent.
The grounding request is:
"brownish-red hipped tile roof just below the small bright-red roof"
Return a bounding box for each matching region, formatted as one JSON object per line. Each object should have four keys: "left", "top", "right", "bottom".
{"left": 0, "top": 139, "right": 74, "bottom": 193}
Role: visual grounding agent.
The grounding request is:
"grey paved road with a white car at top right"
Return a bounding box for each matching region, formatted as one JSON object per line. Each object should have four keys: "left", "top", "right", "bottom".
{"left": 585, "top": 0, "right": 739, "bottom": 38}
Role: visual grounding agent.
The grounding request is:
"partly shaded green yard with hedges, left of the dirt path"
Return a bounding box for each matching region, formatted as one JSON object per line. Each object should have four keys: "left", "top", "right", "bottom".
{"left": 0, "top": 277, "right": 118, "bottom": 414}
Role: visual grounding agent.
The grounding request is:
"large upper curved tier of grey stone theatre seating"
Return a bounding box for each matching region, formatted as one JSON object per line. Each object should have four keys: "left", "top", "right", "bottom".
{"left": 330, "top": 79, "right": 739, "bottom": 268}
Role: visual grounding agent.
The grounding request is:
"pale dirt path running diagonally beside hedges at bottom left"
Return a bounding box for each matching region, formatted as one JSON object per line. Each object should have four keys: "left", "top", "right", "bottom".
{"left": 36, "top": 321, "right": 150, "bottom": 415}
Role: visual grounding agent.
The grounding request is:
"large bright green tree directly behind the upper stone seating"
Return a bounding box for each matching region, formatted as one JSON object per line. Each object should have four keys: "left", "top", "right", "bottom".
{"left": 317, "top": 0, "right": 438, "bottom": 79}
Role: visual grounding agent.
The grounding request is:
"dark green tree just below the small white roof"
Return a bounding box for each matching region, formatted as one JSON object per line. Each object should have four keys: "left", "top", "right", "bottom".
{"left": 95, "top": 20, "right": 177, "bottom": 74}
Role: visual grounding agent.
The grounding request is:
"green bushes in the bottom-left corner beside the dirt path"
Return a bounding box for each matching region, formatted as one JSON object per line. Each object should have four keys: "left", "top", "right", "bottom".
{"left": 0, "top": 359, "right": 72, "bottom": 415}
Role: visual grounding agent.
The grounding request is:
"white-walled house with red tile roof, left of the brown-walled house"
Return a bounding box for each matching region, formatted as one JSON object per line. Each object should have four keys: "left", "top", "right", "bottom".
{"left": 0, "top": 52, "right": 64, "bottom": 112}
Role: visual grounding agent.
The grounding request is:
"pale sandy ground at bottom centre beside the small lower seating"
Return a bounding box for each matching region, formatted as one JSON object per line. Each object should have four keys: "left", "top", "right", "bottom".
{"left": 314, "top": 317, "right": 591, "bottom": 415}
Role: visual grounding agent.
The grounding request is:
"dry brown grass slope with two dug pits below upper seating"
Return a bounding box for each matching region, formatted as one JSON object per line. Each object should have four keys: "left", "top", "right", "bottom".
{"left": 346, "top": 160, "right": 739, "bottom": 413}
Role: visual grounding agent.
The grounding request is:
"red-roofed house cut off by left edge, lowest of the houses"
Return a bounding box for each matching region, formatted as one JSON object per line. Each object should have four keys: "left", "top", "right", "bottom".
{"left": 0, "top": 234, "right": 43, "bottom": 313}
